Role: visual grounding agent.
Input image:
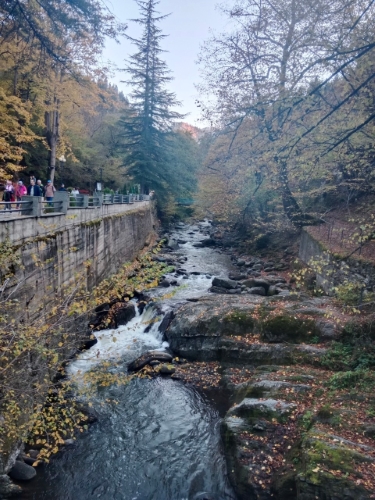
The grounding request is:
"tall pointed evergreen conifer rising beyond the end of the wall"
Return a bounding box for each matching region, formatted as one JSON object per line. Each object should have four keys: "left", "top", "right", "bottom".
{"left": 120, "top": 0, "right": 182, "bottom": 191}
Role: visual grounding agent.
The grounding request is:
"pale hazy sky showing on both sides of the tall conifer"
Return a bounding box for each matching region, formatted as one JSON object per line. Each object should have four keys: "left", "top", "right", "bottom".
{"left": 103, "top": 0, "right": 225, "bottom": 125}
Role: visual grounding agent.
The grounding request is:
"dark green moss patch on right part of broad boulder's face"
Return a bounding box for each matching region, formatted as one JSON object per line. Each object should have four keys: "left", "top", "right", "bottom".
{"left": 260, "top": 314, "right": 320, "bottom": 344}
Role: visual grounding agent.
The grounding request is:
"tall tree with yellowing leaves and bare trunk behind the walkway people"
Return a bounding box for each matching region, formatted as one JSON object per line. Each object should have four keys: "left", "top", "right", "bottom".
{"left": 0, "top": 0, "right": 125, "bottom": 184}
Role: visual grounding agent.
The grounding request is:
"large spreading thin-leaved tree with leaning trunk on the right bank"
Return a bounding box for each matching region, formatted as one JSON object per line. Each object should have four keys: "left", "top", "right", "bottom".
{"left": 201, "top": 0, "right": 375, "bottom": 225}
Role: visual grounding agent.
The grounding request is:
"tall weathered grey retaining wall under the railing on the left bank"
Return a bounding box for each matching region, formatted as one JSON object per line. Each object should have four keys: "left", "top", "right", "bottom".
{"left": 0, "top": 202, "right": 154, "bottom": 312}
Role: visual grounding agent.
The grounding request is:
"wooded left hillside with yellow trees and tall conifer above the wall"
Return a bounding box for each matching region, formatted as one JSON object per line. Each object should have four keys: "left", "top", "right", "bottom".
{"left": 0, "top": 0, "right": 197, "bottom": 213}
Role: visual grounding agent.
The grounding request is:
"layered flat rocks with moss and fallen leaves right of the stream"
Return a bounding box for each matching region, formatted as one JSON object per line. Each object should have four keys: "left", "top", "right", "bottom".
{"left": 128, "top": 223, "right": 375, "bottom": 500}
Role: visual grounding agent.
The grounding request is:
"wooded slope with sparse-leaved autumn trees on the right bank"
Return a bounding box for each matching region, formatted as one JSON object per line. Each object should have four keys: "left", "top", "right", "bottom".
{"left": 200, "top": 0, "right": 375, "bottom": 243}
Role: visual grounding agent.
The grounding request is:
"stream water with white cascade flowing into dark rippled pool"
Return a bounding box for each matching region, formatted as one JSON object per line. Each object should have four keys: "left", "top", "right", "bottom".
{"left": 22, "top": 223, "right": 235, "bottom": 500}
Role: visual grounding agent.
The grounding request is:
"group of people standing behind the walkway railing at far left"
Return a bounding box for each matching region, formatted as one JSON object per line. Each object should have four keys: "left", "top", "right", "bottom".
{"left": 3, "top": 176, "right": 66, "bottom": 210}
